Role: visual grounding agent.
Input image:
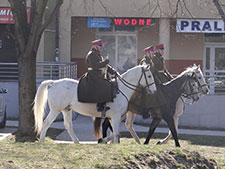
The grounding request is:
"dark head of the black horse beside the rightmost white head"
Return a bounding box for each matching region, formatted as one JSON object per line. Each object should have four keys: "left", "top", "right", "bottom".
{"left": 183, "top": 76, "right": 199, "bottom": 101}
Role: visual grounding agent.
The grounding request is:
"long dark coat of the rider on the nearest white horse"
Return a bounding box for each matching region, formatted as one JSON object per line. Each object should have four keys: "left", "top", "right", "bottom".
{"left": 78, "top": 48, "right": 115, "bottom": 103}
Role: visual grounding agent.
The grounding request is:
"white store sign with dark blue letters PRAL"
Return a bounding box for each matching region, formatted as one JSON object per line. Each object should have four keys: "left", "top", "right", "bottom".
{"left": 176, "top": 19, "right": 225, "bottom": 33}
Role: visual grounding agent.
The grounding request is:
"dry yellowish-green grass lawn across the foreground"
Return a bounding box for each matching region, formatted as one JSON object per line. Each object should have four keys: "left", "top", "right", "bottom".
{"left": 0, "top": 132, "right": 225, "bottom": 169}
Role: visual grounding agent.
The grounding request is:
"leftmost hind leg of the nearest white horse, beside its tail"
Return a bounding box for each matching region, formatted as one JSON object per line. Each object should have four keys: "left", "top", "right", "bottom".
{"left": 40, "top": 110, "right": 59, "bottom": 142}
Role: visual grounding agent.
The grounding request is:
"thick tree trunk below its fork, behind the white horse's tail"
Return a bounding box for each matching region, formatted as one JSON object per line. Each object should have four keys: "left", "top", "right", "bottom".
{"left": 18, "top": 52, "right": 36, "bottom": 138}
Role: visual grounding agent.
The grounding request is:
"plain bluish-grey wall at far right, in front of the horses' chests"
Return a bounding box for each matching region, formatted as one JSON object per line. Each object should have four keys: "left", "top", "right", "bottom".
{"left": 135, "top": 95, "right": 225, "bottom": 130}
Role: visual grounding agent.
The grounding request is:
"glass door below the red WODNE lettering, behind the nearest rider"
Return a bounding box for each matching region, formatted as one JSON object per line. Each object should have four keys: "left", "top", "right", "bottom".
{"left": 97, "top": 33, "right": 137, "bottom": 73}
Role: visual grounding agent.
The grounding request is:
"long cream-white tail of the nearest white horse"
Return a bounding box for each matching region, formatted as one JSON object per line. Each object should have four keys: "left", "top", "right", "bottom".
{"left": 33, "top": 80, "right": 53, "bottom": 135}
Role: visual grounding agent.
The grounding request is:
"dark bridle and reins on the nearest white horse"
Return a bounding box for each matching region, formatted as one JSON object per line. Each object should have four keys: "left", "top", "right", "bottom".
{"left": 116, "top": 67, "right": 155, "bottom": 102}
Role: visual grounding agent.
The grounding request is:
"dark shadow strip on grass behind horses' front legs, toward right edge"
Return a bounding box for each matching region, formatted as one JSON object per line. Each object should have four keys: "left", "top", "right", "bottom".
{"left": 121, "top": 132, "right": 225, "bottom": 147}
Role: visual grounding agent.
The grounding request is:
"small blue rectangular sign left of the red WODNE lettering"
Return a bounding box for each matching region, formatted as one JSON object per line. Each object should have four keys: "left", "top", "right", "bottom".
{"left": 88, "top": 18, "right": 111, "bottom": 28}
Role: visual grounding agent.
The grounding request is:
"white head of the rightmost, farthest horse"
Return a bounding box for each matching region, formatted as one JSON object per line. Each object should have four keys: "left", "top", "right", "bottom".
{"left": 193, "top": 64, "right": 209, "bottom": 95}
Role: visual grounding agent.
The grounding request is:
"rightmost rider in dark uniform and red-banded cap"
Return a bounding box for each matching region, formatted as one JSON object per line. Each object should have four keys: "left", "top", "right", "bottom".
{"left": 152, "top": 44, "right": 173, "bottom": 84}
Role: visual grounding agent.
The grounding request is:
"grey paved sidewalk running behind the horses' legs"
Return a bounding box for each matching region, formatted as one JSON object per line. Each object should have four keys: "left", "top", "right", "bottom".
{"left": 0, "top": 115, "right": 225, "bottom": 144}
